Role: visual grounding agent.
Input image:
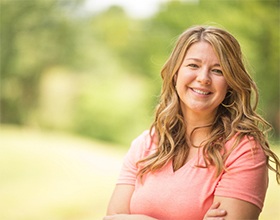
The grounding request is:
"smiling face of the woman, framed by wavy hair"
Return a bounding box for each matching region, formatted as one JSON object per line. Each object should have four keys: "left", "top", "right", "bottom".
{"left": 175, "top": 41, "right": 228, "bottom": 119}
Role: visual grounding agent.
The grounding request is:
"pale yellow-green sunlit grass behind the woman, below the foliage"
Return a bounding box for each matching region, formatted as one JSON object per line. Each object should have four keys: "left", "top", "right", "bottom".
{"left": 0, "top": 126, "right": 280, "bottom": 220}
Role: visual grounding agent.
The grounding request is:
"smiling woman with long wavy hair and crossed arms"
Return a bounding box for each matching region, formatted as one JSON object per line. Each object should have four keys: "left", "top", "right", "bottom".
{"left": 104, "top": 26, "right": 280, "bottom": 220}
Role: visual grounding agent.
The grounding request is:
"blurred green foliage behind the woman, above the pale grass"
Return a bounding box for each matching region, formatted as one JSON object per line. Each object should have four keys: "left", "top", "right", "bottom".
{"left": 0, "top": 0, "right": 280, "bottom": 144}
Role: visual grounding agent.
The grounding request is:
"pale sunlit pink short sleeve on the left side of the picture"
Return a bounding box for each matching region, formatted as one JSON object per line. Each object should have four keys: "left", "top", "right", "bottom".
{"left": 117, "top": 131, "right": 154, "bottom": 185}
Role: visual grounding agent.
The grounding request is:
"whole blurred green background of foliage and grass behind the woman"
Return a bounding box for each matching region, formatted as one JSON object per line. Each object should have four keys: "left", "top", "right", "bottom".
{"left": 0, "top": 0, "right": 280, "bottom": 220}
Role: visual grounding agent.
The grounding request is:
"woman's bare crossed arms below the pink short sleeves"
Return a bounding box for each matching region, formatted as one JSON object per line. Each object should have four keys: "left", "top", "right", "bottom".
{"left": 103, "top": 185, "right": 260, "bottom": 220}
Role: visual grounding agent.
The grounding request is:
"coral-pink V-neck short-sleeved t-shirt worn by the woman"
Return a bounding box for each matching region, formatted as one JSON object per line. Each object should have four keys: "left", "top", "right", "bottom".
{"left": 117, "top": 131, "right": 268, "bottom": 220}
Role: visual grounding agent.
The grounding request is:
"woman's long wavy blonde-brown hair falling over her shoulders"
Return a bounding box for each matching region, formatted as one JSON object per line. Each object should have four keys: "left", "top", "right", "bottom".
{"left": 138, "top": 26, "right": 280, "bottom": 183}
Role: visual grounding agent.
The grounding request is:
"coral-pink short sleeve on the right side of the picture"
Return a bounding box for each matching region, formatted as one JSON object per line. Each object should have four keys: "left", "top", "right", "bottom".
{"left": 215, "top": 138, "right": 268, "bottom": 210}
